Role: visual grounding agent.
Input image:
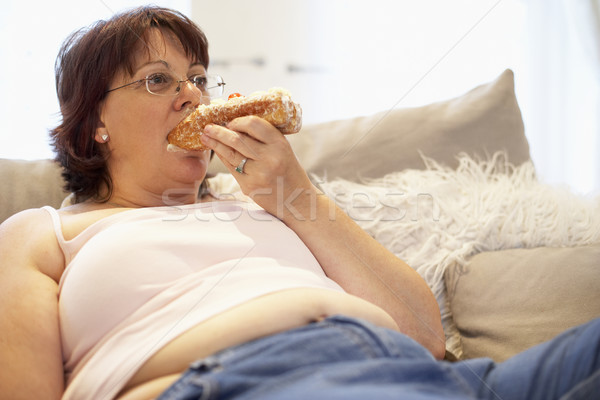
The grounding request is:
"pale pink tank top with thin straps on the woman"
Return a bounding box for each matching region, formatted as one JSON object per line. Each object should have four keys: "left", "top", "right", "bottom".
{"left": 45, "top": 201, "right": 342, "bottom": 399}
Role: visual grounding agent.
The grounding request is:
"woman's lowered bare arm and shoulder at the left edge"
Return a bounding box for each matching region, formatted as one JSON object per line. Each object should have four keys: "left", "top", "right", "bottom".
{"left": 0, "top": 210, "right": 64, "bottom": 400}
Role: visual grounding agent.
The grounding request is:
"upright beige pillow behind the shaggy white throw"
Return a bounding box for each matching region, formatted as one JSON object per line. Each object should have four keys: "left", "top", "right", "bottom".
{"left": 209, "top": 70, "right": 530, "bottom": 180}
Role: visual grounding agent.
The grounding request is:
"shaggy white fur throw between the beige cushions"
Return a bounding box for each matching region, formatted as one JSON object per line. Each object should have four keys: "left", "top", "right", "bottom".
{"left": 319, "top": 152, "right": 600, "bottom": 357}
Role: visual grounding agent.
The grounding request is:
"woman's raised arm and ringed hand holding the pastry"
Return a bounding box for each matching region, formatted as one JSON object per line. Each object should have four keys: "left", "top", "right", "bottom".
{"left": 202, "top": 117, "right": 445, "bottom": 358}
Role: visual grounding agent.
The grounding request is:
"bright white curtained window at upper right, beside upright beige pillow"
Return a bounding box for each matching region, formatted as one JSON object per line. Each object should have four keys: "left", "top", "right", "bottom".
{"left": 521, "top": 0, "right": 600, "bottom": 194}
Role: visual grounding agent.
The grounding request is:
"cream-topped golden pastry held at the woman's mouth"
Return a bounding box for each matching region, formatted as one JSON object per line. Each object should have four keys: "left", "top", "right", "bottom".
{"left": 167, "top": 88, "right": 302, "bottom": 150}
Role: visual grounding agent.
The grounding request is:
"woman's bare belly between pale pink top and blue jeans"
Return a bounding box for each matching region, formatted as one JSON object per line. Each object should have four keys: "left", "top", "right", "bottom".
{"left": 117, "top": 289, "right": 398, "bottom": 400}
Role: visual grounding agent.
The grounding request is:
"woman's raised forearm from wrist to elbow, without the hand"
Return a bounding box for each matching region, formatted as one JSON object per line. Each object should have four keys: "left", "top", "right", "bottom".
{"left": 283, "top": 194, "right": 445, "bottom": 358}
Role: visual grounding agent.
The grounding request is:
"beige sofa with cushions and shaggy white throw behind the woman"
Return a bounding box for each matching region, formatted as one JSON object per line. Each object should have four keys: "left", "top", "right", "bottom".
{"left": 0, "top": 70, "right": 600, "bottom": 361}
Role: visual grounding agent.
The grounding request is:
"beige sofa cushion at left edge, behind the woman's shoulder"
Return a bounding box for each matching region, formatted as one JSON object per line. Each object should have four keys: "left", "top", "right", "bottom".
{"left": 0, "top": 159, "right": 67, "bottom": 222}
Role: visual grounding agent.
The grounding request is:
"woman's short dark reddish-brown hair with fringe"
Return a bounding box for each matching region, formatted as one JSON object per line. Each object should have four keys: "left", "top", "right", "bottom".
{"left": 50, "top": 6, "right": 209, "bottom": 203}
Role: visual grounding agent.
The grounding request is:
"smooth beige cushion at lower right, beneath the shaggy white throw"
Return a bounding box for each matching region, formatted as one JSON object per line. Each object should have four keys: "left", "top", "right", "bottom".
{"left": 446, "top": 244, "right": 600, "bottom": 361}
